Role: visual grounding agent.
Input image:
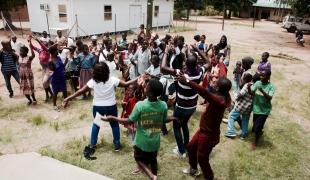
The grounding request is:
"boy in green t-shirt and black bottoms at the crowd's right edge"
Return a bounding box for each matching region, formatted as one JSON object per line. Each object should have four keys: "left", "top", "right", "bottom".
{"left": 251, "top": 70, "right": 275, "bottom": 150}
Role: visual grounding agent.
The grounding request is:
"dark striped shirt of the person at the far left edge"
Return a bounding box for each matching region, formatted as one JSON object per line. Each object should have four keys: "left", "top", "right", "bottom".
{"left": 0, "top": 52, "right": 17, "bottom": 72}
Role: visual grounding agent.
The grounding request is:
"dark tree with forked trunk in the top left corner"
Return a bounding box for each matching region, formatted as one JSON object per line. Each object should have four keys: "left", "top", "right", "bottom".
{"left": 0, "top": 0, "right": 26, "bottom": 30}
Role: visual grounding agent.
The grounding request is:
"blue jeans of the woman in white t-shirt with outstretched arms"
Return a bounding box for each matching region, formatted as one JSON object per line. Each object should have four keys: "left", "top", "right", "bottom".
{"left": 90, "top": 105, "right": 121, "bottom": 149}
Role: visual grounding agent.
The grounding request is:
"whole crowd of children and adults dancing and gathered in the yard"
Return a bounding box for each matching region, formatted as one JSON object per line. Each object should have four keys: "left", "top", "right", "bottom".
{"left": 0, "top": 25, "right": 275, "bottom": 179}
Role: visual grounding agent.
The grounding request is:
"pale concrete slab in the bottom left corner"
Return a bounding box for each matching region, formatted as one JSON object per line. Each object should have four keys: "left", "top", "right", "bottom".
{"left": 0, "top": 152, "right": 110, "bottom": 180}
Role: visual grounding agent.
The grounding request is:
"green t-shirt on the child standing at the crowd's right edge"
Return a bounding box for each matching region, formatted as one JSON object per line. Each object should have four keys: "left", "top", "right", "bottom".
{"left": 251, "top": 81, "right": 275, "bottom": 115}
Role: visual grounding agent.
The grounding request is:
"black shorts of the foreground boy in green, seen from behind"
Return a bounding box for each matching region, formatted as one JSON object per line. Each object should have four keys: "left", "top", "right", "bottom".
{"left": 133, "top": 146, "right": 157, "bottom": 165}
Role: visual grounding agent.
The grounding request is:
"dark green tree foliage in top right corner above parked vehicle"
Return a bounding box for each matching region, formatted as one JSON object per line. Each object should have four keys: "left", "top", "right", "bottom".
{"left": 289, "top": 0, "right": 310, "bottom": 17}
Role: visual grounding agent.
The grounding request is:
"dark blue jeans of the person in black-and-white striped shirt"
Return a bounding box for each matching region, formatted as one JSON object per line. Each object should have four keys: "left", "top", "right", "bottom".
{"left": 173, "top": 106, "right": 196, "bottom": 154}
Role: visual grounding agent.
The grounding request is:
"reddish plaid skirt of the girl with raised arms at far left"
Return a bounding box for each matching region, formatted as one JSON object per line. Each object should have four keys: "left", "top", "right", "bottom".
{"left": 19, "top": 69, "right": 34, "bottom": 95}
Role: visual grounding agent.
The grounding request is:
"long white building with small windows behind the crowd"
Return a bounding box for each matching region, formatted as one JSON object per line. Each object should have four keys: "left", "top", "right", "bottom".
{"left": 27, "top": 0, "right": 174, "bottom": 37}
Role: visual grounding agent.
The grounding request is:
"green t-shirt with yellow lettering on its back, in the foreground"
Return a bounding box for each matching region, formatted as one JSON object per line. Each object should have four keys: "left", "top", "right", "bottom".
{"left": 129, "top": 99, "right": 168, "bottom": 152}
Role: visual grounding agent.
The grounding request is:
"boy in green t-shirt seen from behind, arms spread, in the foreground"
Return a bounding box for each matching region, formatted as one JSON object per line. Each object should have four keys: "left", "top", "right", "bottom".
{"left": 102, "top": 79, "right": 173, "bottom": 179}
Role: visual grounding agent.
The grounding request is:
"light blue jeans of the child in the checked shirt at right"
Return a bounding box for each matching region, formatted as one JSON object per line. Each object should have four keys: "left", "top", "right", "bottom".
{"left": 225, "top": 109, "right": 250, "bottom": 137}
